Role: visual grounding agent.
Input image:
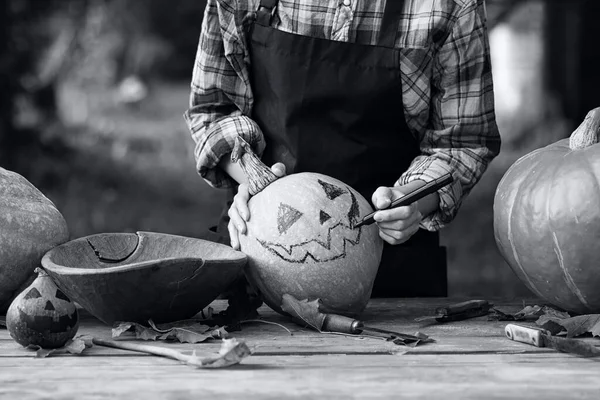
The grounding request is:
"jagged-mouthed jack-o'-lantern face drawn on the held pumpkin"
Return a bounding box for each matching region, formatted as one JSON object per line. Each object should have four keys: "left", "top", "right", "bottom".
{"left": 252, "top": 179, "right": 362, "bottom": 263}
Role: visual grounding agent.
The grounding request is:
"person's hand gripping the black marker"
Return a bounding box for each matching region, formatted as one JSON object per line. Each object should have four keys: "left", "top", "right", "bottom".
{"left": 371, "top": 186, "right": 423, "bottom": 245}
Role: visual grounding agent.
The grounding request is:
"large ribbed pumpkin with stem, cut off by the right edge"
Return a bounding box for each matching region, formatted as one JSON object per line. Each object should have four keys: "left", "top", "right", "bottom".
{"left": 494, "top": 108, "right": 600, "bottom": 313}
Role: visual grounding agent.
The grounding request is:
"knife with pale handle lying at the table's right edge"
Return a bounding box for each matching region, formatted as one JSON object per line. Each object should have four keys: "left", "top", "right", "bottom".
{"left": 504, "top": 324, "right": 600, "bottom": 357}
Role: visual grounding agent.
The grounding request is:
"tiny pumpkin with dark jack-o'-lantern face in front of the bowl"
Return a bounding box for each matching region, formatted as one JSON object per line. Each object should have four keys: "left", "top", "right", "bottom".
{"left": 6, "top": 268, "right": 79, "bottom": 349}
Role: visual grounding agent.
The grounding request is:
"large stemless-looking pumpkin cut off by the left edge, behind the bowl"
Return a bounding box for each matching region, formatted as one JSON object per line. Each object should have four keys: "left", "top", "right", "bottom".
{"left": 0, "top": 168, "right": 69, "bottom": 313}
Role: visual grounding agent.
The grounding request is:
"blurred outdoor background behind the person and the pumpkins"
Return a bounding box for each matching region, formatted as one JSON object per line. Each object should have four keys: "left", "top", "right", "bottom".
{"left": 0, "top": 0, "right": 600, "bottom": 297}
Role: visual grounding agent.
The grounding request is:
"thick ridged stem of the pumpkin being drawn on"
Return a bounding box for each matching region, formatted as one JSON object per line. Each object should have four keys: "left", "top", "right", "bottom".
{"left": 231, "top": 136, "right": 278, "bottom": 196}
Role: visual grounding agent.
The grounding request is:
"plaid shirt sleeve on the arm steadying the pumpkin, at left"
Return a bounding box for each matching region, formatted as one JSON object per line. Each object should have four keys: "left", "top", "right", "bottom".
{"left": 184, "top": 0, "right": 265, "bottom": 188}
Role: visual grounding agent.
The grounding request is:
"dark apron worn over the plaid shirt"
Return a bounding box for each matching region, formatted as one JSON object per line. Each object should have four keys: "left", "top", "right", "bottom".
{"left": 213, "top": 0, "right": 447, "bottom": 297}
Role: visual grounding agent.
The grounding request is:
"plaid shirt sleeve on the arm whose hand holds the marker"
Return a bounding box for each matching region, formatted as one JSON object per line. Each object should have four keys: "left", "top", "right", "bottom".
{"left": 396, "top": 0, "right": 500, "bottom": 231}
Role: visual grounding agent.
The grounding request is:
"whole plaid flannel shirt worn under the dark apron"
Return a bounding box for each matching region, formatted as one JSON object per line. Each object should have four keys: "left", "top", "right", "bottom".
{"left": 184, "top": 0, "right": 500, "bottom": 230}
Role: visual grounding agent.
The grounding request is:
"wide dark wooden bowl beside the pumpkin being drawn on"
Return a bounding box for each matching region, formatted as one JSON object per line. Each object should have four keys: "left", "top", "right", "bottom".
{"left": 42, "top": 232, "right": 246, "bottom": 324}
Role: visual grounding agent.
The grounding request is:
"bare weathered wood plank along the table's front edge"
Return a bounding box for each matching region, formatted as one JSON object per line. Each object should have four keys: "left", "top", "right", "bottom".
{"left": 0, "top": 354, "right": 600, "bottom": 400}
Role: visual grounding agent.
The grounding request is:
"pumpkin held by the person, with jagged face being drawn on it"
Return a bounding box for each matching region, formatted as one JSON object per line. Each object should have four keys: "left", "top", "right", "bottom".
{"left": 234, "top": 141, "right": 383, "bottom": 315}
